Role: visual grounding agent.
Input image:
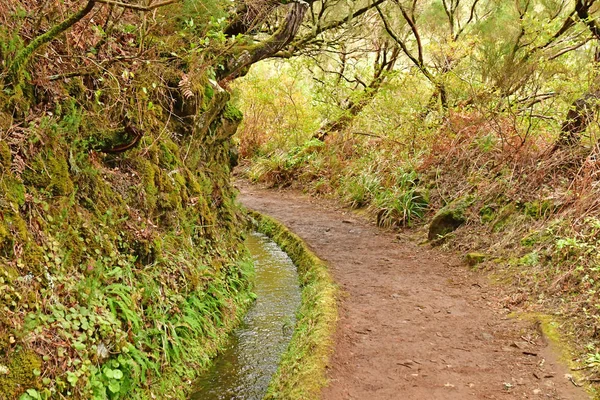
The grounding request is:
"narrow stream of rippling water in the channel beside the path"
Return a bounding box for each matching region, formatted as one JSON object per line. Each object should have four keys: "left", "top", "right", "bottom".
{"left": 190, "top": 233, "right": 301, "bottom": 400}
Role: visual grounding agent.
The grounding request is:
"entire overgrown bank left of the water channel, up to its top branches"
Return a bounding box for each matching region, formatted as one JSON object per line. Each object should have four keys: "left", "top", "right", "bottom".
{"left": 0, "top": 0, "right": 274, "bottom": 399}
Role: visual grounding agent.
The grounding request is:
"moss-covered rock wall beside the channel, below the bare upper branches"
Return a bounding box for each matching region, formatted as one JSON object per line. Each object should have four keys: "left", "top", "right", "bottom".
{"left": 0, "top": 57, "right": 252, "bottom": 400}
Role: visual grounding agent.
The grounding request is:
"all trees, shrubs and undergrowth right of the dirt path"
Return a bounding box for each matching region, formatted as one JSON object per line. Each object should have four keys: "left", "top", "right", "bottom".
{"left": 235, "top": 0, "right": 600, "bottom": 390}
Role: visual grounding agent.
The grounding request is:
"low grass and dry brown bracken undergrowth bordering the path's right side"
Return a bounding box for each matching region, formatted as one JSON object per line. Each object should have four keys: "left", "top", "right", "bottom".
{"left": 244, "top": 108, "right": 600, "bottom": 388}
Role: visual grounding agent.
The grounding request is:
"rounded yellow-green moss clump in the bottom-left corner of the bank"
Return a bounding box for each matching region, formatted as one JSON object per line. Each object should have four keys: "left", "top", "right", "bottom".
{"left": 0, "top": 349, "right": 42, "bottom": 399}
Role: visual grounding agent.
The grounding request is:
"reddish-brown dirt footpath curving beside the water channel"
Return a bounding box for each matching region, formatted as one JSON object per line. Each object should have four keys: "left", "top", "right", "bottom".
{"left": 238, "top": 183, "right": 589, "bottom": 400}
